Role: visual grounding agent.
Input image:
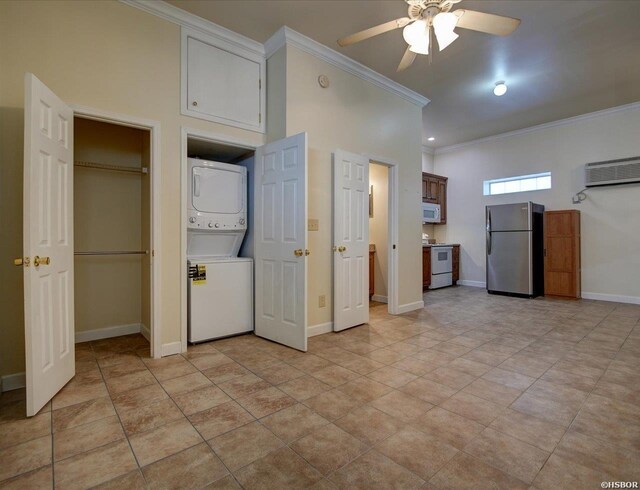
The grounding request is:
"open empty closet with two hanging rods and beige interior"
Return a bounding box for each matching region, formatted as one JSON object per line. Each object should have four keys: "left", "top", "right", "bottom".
{"left": 73, "top": 115, "right": 155, "bottom": 357}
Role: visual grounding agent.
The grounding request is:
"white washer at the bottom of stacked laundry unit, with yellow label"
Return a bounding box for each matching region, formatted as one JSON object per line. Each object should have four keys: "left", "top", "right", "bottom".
{"left": 187, "top": 259, "right": 253, "bottom": 342}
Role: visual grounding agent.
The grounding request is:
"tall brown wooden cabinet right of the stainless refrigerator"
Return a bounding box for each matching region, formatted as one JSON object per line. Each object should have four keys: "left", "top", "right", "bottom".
{"left": 544, "top": 209, "right": 581, "bottom": 298}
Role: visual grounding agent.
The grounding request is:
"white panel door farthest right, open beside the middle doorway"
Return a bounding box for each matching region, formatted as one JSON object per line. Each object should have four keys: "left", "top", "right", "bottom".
{"left": 333, "top": 150, "right": 369, "bottom": 332}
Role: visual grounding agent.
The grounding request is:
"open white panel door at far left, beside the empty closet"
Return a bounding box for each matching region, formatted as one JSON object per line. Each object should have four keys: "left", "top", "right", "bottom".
{"left": 23, "top": 73, "right": 75, "bottom": 416}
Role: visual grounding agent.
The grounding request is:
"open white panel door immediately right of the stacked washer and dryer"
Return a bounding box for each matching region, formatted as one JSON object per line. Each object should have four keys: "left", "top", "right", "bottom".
{"left": 254, "top": 133, "right": 308, "bottom": 351}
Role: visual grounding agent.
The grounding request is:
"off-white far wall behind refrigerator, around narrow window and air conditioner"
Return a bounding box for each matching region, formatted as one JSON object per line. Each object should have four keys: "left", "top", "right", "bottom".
{"left": 435, "top": 108, "right": 640, "bottom": 302}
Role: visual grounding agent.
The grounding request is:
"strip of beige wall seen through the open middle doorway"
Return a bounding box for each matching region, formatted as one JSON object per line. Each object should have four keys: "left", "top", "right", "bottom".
{"left": 369, "top": 163, "right": 389, "bottom": 297}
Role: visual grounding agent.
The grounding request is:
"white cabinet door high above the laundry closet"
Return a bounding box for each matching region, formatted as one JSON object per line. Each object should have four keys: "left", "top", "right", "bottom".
{"left": 181, "top": 28, "right": 266, "bottom": 133}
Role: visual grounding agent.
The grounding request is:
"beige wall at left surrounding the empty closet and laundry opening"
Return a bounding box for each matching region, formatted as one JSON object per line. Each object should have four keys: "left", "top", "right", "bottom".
{"left": 0, "top": 1, "right": 264, "bottom": 375}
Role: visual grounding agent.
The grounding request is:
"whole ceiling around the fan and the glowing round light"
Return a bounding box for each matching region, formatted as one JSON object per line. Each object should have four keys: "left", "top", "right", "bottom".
{"left": 169, "top": 0, "right": 640, "bottom": 148}
